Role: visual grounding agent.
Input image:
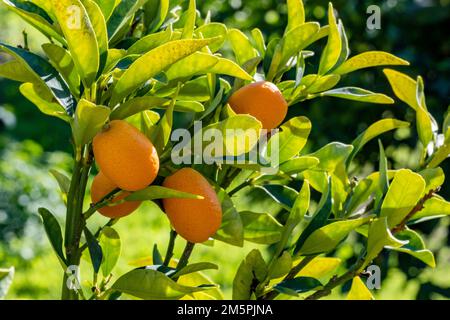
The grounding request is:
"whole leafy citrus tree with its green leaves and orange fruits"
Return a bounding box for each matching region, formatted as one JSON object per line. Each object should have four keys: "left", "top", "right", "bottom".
{"left": 0, "top": 0, "right": 450, "bottom": 300}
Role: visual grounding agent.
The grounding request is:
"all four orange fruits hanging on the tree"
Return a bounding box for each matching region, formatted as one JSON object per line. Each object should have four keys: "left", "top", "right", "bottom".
{"left": 91, "top": 82, "right": 287, "bottom": 243}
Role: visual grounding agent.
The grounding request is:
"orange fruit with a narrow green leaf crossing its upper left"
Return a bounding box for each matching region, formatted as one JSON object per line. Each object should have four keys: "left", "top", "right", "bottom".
{"left": 163, "top": 168, "right": 222, "bottom": 243}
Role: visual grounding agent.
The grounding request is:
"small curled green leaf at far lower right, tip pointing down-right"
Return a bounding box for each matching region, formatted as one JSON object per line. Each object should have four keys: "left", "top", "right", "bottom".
{"left": 393, "top": 229, "right": 436, "bottom": 268}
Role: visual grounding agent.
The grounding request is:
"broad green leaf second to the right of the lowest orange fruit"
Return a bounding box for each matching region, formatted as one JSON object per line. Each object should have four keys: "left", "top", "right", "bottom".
{"left": 239, "top": 211, "right": 283, "bottom": 244}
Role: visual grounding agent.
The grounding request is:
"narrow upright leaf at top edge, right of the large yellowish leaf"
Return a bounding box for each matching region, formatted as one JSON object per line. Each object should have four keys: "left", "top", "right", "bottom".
{"left": 82, "top": 0, "right": 108, "bottom": 72}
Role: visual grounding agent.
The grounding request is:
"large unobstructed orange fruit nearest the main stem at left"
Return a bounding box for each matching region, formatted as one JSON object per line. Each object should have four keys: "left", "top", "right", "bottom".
{"left": 93, "top": 120, "right": 159, "bottom": 191}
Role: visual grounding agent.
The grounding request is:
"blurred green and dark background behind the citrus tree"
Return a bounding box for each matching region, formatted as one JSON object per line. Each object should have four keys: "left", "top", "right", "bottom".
{"left": 0, "top": 0, "right": 450, "bottom": 299}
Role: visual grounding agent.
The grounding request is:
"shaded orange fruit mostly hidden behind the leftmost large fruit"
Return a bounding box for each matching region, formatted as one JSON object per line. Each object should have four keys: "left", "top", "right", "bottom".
{"left": 91, "top": 172, "right": 141, "bottom": 219}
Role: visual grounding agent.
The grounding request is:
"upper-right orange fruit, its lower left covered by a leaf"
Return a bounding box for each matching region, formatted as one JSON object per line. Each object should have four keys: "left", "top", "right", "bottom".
{"left": 228, "top": 81, "right": 288, "bottom": 130}
